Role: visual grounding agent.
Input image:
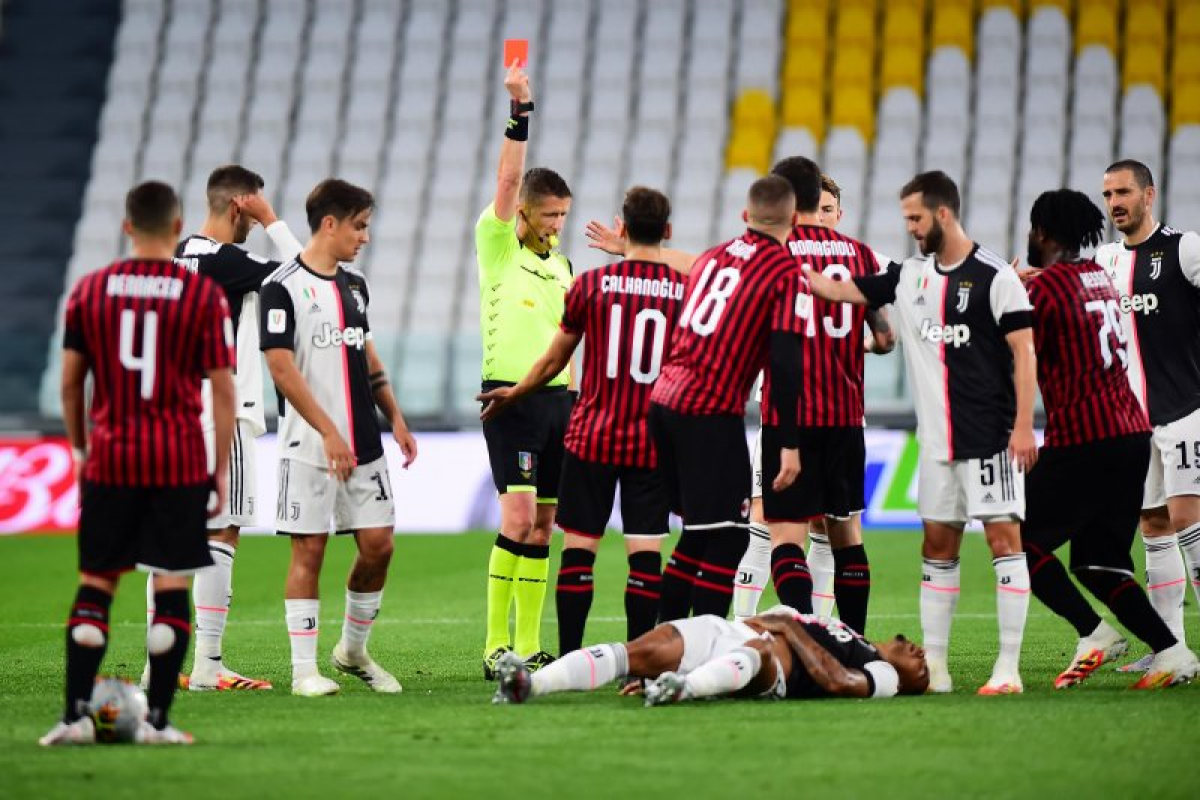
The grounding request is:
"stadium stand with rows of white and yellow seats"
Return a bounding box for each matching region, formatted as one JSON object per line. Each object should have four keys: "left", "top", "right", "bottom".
{"left": 7, "top": 0, "right": 1200, "bottom": 425}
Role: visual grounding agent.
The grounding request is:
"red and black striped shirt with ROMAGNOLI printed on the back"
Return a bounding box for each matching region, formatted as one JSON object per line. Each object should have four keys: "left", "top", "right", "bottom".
{"left": 762, "top": 225, "right": 880, "bottom": 428}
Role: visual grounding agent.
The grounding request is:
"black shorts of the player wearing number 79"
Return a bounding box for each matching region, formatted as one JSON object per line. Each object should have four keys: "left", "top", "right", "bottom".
{"left": 1021, "top": 433, "right": 1150, "bottom": 571}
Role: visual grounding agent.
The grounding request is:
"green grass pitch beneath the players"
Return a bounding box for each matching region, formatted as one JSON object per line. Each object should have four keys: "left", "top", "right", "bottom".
{"left": 0, "top": 533, "right": 1200, "bottom": 800}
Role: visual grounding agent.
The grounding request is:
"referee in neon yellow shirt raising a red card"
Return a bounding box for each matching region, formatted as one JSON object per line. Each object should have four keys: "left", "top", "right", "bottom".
{"left": 475, "top": 62, "right": 571, "bottom": 680}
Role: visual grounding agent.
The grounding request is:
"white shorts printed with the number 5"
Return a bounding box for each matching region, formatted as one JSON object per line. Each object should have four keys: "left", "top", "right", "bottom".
{"left": 917, "top": 447, "right": 1025, "bottom": 524}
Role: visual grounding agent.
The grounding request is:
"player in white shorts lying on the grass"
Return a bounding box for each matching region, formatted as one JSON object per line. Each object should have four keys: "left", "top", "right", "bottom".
{"left": 493, "top": 606, "right": 929, "bottom": 705}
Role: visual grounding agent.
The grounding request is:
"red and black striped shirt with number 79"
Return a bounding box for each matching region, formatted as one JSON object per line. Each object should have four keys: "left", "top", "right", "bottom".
{"left": 1028, "top": 260, "right": 1150, "bottom": 447}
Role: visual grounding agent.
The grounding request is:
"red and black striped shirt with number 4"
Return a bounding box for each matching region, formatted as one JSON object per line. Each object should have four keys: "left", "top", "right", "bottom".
{"left": 62, "top": 259, "right": 234, "bottom": 486}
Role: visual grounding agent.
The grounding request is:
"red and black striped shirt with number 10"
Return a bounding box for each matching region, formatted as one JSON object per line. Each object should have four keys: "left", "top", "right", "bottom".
{"left": 563, "top": 261, "right": 686, "bottom": 467}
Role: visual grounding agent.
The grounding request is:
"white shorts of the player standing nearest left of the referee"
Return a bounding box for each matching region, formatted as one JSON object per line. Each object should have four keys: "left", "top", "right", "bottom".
{"left": 275, "top": 456, "right": 396, "bottom": 535}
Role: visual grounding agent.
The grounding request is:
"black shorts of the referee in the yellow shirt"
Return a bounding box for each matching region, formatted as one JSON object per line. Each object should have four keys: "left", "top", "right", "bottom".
{"left": 484, "top": 380, "right": 572, "bottom": 503}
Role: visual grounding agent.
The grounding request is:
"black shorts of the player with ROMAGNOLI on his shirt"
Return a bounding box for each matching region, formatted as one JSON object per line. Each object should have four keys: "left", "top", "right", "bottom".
{"left": 762, "top": 426, "right": 866, "bottom": 522}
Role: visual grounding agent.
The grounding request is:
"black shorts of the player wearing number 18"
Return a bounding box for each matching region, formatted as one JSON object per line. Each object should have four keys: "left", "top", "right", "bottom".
{"left": 649, "top": 403, "right": 751, "bottom": 529}
